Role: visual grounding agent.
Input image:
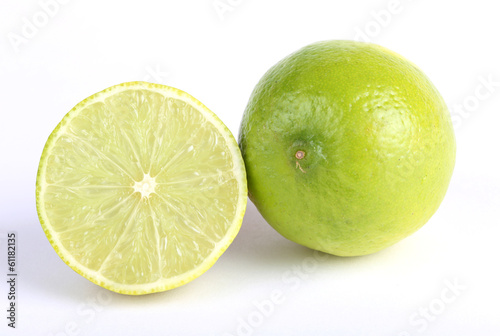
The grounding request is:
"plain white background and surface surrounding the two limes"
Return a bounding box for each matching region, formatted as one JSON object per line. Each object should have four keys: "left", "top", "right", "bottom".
{"left": 0, "top": 0, "right": 500, "bottom": 336}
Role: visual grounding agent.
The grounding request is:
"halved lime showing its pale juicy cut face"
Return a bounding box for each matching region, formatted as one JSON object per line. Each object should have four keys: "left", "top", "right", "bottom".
{"left": 36, "top": 82, "right": 247, "bottom": 294}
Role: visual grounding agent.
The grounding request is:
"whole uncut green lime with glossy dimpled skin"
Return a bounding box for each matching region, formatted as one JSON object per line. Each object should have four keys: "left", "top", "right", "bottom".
{"left": 239, "top": 41, "right": 456, "bottom": 256}
